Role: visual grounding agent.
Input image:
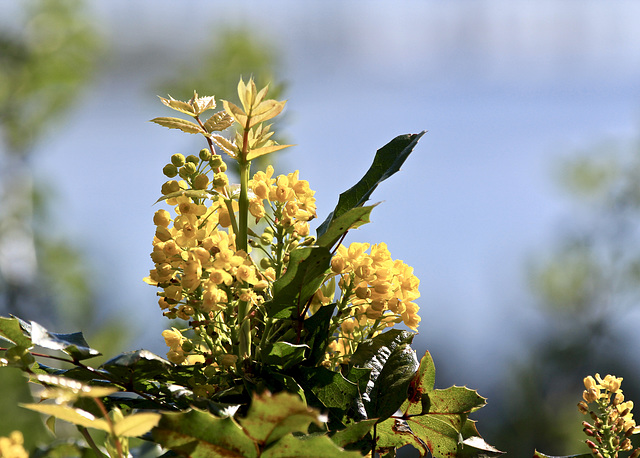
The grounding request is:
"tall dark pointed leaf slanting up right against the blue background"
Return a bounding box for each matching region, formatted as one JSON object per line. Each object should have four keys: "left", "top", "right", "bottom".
{"left": 317, "top": 131, "right": 425, "bottom": 238}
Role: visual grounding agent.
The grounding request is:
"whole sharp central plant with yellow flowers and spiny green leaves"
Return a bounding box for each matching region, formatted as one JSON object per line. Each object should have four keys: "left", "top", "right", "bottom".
{"left": 0, "top": 79, "right": 510, "bottom": 458}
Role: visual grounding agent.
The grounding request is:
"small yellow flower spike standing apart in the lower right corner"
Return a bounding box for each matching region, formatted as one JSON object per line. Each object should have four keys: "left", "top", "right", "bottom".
{"left": 578, "top": 374, "right": 640, "bottom": 458}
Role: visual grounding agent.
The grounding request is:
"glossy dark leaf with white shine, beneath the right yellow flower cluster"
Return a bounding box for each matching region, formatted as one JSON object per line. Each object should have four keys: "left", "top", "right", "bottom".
{"left": 351, "top": 329, "right": 419, "bottom": 419}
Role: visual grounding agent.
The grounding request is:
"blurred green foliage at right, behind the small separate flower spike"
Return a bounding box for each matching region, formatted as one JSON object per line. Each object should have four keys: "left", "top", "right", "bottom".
{"left": 481, "top": 135, "right": 640, "bottom": 456}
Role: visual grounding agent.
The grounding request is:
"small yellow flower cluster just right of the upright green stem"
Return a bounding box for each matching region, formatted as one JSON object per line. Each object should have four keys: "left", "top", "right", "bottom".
{"left": 249, "top": 165, "right": 316, "bottom": 231}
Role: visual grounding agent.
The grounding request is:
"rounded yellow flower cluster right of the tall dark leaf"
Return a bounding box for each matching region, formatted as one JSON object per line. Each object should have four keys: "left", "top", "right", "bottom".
{"left": 331, "top": 243, "right": 420, "bottom": 331}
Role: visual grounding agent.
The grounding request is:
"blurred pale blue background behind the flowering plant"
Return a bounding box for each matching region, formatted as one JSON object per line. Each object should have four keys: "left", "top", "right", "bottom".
{"left": 5, "top": 0, "right": 640, "bottom": 394}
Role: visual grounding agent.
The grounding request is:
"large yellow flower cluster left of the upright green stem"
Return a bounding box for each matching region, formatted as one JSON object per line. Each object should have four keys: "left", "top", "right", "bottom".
{"left": 145, "top": 183, "right": 267, "bottom": 320}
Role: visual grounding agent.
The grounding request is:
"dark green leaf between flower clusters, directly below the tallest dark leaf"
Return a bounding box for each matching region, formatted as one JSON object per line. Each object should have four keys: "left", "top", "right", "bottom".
{"left": 265, "top": 246, "right": 331, "bottom": 319}
